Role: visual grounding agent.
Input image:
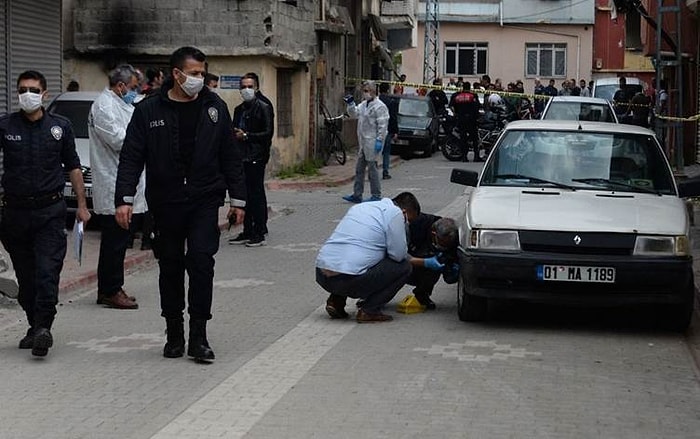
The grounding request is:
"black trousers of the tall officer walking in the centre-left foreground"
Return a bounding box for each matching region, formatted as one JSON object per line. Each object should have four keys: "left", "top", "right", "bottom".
{"left": 151, "top": 202, "right": 221, "bottom": 320}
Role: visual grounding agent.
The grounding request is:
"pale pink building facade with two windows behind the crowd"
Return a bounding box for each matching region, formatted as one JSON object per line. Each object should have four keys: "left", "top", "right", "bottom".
{"left": 401, "top": 0, "right": 594, "bottom": 91}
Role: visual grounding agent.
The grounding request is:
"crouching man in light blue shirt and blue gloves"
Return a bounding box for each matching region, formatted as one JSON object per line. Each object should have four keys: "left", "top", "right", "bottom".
{"left": 316, "top": 195, "right": 413, "bottom": 323}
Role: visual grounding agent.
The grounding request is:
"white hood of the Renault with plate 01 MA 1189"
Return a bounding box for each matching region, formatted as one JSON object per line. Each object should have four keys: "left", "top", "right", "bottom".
{"left": 467, "top": 186, "right": 688, "bottom": 235}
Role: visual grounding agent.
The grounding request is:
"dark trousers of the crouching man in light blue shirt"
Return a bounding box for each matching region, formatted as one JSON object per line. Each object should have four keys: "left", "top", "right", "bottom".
{"left": 316, "top": 258, "right": 411, "bottom": 313}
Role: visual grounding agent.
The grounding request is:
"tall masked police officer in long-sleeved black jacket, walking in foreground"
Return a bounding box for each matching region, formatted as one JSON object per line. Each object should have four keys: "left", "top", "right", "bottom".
{"left": 114, "top": 47, "right": 246, "bottom": 361}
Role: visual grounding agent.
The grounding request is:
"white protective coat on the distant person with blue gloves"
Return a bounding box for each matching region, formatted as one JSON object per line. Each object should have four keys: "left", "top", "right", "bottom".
{"left": 347, "top": 97, "right": 389, "bottom": 162}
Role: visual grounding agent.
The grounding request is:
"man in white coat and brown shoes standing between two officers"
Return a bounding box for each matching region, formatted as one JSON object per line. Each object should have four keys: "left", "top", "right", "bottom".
{"left": 88, "top": 64, "right": 146, "bottom": 309}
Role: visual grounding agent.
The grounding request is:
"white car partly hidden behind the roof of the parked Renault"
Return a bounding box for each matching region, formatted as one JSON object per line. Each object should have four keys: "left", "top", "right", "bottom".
{"left": 540, "top": 96, "right": 618, "bottom": 123}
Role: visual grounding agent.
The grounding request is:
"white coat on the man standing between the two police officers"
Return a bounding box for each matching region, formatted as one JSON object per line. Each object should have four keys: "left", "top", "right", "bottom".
{"left": 88, "top": 88, "right": 148, "bottom": 215}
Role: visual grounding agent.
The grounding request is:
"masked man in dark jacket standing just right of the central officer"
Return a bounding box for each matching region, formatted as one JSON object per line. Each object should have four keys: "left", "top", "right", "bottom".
{"left": 229, "top": 75, "right": 272, "bottom": 247}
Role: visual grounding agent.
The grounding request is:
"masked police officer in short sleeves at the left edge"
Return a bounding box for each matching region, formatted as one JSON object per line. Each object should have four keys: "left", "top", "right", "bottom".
{"left": 0, "top": 70, "right": 90, "bottom": 357}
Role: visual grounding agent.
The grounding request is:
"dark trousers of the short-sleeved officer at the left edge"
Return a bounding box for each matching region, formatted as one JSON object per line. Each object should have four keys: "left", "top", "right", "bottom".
{"left": 0, "top": 200, "right": 66, "bottom": 329}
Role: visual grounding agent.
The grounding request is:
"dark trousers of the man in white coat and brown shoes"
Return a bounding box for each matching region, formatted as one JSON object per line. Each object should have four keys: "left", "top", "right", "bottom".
{"left": 97, "top": 215, "right": 129, "bottom": 296}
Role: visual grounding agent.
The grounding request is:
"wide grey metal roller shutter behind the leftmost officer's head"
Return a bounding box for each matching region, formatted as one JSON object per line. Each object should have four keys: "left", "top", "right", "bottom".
{"left": 4, "top": 0, "right": 62, "bottom": 111}
